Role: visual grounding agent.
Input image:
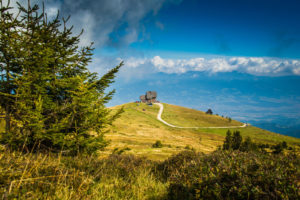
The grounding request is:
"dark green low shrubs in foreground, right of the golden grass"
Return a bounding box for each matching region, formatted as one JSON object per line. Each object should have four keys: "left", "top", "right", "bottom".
{"left": 165, "top": 151, "right": 300, "bottom": 199}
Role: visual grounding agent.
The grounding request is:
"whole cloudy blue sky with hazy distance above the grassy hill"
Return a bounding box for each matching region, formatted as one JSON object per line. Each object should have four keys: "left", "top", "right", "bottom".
{"left": 4, "top": 0, "right": 300, "bottom": 137}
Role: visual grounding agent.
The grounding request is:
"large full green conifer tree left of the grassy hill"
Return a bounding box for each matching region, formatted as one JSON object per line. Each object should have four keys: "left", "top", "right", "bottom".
{"left": 0, "top": 0, "right": 123, "bottom": 153}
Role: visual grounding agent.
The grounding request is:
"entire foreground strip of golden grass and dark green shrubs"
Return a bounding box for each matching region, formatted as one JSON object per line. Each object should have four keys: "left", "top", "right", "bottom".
{"left": 0, "top": 145, "right": 300, "bottom": 199}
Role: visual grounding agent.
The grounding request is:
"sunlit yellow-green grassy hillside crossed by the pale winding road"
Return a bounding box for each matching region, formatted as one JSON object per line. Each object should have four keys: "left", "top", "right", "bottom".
{"left": 106, "top": 103, "right": 300, "bottom": 160}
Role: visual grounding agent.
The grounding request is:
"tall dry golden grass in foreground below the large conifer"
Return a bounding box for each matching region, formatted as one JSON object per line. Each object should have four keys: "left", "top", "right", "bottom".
{"left": 0, "top": 149, "right": 168, "bottom": 200}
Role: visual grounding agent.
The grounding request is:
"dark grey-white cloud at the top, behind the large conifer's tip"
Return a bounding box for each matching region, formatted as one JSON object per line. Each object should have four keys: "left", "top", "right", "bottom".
{"left": 3, "top": 0, "right": 181, "bottom": 47}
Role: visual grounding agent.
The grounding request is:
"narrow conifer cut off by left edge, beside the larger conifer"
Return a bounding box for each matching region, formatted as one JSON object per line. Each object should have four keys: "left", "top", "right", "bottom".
{"left": 0, "top": 0, "right": 21, "bottom": 132}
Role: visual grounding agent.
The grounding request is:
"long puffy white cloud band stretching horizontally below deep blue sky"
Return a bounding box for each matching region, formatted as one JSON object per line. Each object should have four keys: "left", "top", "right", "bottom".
{"left": 125, "top": 56, "right": 300, "bottom": 76}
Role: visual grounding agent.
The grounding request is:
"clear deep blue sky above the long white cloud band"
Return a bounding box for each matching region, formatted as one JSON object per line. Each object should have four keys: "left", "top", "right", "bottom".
{"left": 132, "top": 0, "right": 300, "bottom": 58}
